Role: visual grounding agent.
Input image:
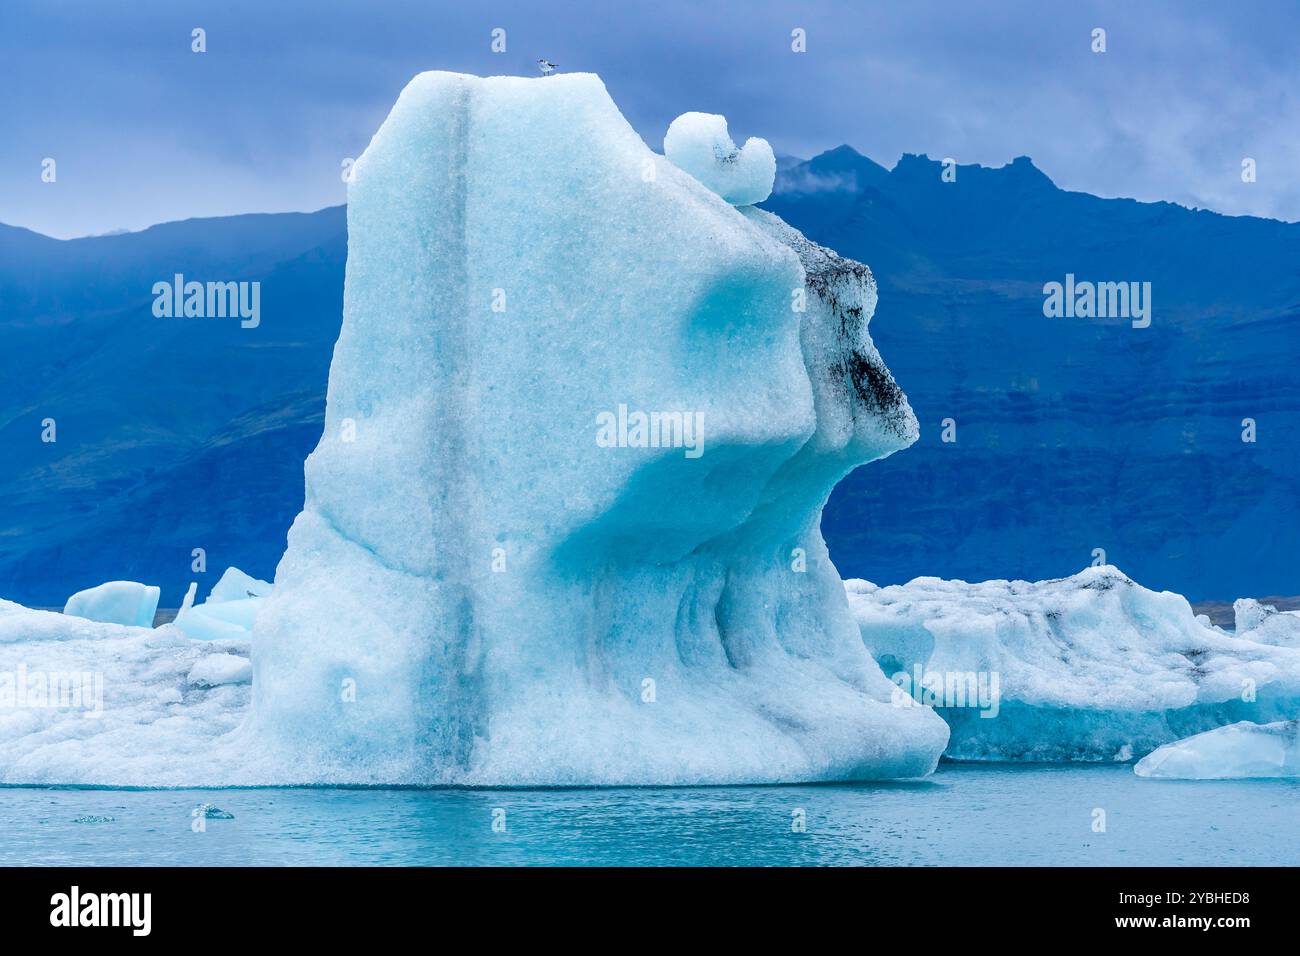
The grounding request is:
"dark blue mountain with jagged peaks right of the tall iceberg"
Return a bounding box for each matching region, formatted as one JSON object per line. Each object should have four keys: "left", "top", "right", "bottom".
{"left": 767, "top": 147, "right": 1300, "bottom": 597}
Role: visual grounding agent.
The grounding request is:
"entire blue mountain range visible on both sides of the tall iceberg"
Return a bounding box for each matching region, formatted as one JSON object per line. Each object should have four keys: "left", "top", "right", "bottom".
{"left": 0, "top": 147, "right": 1300, "bottom": 605}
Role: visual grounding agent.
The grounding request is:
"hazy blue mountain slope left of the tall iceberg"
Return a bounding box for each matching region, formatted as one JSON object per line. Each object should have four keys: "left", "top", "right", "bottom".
{"left": 0, "top": 207, "right": 347, "bottom": 606}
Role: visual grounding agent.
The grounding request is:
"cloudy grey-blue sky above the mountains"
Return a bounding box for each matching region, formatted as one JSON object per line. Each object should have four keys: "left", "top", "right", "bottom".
{"left": 0, "top": 0, "right": 1300, "bottom": 237}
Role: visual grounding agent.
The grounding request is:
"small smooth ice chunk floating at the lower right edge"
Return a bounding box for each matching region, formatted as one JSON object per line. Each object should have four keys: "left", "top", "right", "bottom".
{"left": 1134, "top": 721, "right": 1300, "bottom": 780}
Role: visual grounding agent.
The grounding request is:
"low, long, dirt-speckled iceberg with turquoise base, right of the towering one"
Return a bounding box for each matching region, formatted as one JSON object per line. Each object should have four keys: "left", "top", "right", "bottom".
{"left": 845, "top": 566, "right": 1300, "bottom": 761}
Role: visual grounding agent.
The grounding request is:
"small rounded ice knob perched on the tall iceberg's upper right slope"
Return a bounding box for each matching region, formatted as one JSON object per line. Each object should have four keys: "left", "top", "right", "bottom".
{"left": 663, "top": 113, "right": 776, "bottom": 206}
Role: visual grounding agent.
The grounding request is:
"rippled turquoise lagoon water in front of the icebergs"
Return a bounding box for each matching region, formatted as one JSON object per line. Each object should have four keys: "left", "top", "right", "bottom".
{"left": 0, "top": 763, "right": 1300, "bottom": 866}
